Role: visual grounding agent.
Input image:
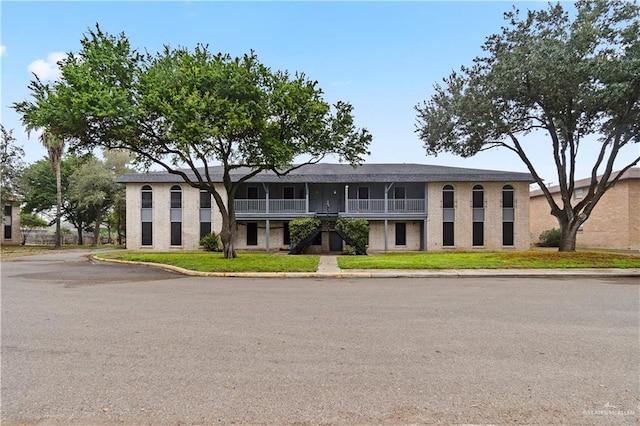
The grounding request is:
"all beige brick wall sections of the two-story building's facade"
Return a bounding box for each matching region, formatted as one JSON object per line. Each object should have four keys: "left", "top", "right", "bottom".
{"left": 127, "top": 182, "right": 529, "bottom": 251}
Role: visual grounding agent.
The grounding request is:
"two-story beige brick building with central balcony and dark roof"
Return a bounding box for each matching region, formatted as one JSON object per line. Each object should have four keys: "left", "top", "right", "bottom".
{"left": 118, "top": 164, "right": 533, "bottom": 252}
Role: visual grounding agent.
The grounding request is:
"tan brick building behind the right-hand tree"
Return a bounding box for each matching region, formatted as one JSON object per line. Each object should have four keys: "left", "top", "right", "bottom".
{"left": 529, "top": 167, "right": 640, "bottom": 250}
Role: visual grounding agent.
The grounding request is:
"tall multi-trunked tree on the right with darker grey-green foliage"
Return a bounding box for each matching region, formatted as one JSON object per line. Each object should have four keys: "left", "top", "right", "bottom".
{"left": 416, "top": 0, "right": 640, "bottom": 251}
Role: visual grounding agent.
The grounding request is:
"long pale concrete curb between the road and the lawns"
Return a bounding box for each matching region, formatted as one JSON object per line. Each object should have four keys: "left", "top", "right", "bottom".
{"left": 88, "top": 254, "right": 640, "bottom": 284}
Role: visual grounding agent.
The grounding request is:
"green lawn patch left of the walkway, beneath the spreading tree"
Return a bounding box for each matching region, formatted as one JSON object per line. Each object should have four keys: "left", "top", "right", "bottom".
{"left": 98, "top": 251, "right": 320, "bottom": 272}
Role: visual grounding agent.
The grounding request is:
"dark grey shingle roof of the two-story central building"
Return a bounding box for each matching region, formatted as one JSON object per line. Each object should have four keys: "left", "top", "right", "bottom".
{"left": 117, "top": 163, "right": 533, "bottom": 183}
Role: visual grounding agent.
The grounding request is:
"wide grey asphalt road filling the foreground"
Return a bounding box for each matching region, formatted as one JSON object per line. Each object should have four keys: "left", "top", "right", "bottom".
{"left": 1, "top": 253, "right": 640, "bottom": 425}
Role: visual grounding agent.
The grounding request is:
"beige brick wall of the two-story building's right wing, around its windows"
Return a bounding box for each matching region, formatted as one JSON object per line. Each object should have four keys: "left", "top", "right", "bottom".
{"left": 427, "top": 182, "right": 530, "bottom": 251}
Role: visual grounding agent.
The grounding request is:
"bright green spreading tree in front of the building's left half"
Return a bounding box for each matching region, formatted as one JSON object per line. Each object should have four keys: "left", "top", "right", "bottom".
{"left": 14, "top": 27, "right": 371, "bottom": 258}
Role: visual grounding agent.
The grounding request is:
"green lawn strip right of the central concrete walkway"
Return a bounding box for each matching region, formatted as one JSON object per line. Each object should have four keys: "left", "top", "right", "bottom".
{"left": 338, "top": 251, "right": 640, "bottom": 269}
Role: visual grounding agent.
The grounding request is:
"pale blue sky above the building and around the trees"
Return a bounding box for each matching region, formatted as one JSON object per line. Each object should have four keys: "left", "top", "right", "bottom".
{"left": 0, "top": 1, "right": 637, "bottom": 183}
